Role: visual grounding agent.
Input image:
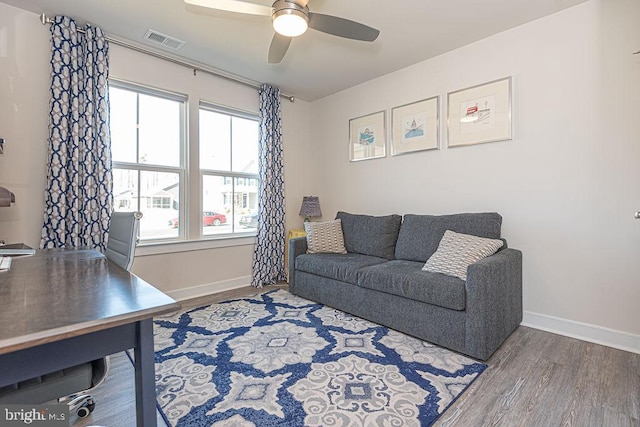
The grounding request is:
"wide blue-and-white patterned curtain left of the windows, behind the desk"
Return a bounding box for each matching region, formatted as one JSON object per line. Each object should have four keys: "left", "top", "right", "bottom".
{"left": 40, "top": 16, "right": 113, "bottom": 250}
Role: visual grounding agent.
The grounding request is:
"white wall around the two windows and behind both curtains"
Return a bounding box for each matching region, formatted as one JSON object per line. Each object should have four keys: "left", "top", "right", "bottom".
{"left": 0, "top": 3, "right": 310, "bottom": 298}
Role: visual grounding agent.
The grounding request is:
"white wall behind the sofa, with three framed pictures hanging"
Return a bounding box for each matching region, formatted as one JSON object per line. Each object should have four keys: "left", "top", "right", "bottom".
{"left": 311, "top": 0, "right": 640, "bottom": 352}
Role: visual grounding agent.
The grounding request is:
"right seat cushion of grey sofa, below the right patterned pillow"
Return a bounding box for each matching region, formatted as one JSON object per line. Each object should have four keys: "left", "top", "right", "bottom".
{"left": 358, "top": 260, "right": 466, "bottom": 311}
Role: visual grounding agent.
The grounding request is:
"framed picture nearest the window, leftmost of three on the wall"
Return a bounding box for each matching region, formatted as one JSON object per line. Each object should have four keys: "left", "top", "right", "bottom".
{"left": 349, "top": 110, "right": 387, "bottom": 162}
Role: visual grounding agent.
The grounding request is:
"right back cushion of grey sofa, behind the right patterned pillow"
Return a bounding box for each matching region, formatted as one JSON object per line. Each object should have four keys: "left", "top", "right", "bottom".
{"left": 396, "top": 212, "right": 502, "bottom": 262}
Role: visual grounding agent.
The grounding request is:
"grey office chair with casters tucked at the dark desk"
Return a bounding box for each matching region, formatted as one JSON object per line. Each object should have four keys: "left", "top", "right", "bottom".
{"left": 0, "top": 212, "right": 142, "bottom": 418}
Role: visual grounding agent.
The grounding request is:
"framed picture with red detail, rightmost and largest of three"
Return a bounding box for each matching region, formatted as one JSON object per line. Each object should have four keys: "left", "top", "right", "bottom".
{"left": 447, "top": 76, "right": 512, "bottom": 147}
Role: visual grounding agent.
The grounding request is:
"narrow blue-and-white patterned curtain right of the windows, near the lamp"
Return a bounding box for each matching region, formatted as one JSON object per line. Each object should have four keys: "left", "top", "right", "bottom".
{"left": 251, "top": 85, "right": 287, "bottom": 288}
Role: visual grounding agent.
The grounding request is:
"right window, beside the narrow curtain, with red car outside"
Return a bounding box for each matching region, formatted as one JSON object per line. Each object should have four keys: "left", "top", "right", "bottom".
{"left": 199, "top": 103, "right": 259, "bottom": 235}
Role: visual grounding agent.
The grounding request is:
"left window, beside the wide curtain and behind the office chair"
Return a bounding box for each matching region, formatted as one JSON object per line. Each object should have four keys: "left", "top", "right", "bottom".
{"left": 109, "top": 81, "right": 186, "bottom": 239}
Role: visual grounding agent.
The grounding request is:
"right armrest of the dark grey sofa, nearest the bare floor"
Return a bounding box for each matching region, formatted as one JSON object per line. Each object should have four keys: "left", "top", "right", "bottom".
{"left": 466, "top": 248, "right": 522, "bottom": 360}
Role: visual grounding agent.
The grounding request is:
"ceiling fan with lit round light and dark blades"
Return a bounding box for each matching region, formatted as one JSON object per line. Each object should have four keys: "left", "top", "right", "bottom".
{"left": 184, "top": 0, "right": 380, "bottom": 64}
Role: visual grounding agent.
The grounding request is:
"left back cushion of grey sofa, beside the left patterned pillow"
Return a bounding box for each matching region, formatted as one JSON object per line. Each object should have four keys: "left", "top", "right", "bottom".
{"left": 336, "top": 212, "right": 402, "bottom": 259}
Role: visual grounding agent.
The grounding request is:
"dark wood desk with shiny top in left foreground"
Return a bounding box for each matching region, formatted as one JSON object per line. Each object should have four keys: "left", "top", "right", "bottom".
{"left": 0, "top": 250, "right": 180, "bottom": 427}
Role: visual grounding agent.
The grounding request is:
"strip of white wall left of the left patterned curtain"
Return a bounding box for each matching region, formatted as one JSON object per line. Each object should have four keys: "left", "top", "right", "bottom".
{"left": 0, "top": 3, "right": 50, "bottom": 247}
